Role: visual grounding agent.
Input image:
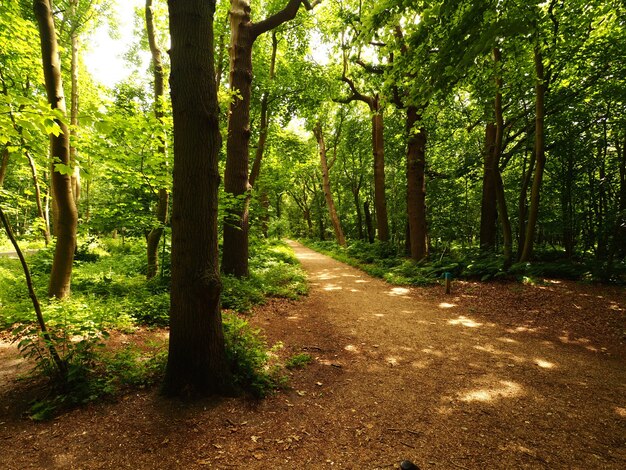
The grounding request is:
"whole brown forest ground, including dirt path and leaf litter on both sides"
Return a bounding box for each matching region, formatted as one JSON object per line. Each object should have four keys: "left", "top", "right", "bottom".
{"left": 0, "top": 243, "right": 626, "bottom": 469}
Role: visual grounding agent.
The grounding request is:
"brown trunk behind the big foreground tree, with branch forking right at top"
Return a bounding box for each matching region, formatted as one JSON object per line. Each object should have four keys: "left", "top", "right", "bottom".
{"left": 222, "top": 0, "right": 302, "bottom": 277}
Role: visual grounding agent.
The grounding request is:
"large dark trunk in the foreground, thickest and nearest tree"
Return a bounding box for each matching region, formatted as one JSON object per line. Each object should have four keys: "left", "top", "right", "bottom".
{"left": 163, "top": 0, "right": 232, "bottom": 396}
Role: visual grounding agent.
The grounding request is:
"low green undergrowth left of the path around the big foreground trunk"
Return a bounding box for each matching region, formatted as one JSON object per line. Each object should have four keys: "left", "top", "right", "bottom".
{"left": 0, "top": 237, "right": 307, "bottom": 419}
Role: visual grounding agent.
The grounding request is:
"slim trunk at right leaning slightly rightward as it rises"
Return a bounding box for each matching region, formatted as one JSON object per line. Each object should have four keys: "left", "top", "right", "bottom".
{"left": 520, "top": 45, "right": 546, "bottom": 262}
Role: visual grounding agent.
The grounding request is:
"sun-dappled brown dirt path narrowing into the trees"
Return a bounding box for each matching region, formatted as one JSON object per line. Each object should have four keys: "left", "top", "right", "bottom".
{"left": 278, "top": 242, "right": 626, "bottom": 469}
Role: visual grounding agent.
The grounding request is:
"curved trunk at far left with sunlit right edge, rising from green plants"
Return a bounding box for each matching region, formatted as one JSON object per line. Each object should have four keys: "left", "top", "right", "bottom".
{"left": 33, "top": 0, "right": 78, "bottom": 299}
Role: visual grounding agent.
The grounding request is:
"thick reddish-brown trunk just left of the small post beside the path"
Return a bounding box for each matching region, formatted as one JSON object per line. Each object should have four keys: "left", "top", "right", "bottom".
{"left": 406, "top": 106, "right": 428, "bottom": 261}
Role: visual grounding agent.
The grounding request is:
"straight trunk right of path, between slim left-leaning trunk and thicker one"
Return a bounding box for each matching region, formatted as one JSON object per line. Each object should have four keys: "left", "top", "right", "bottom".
{"left": 371, "top": 104, "right": 389, "bottom": 242}
